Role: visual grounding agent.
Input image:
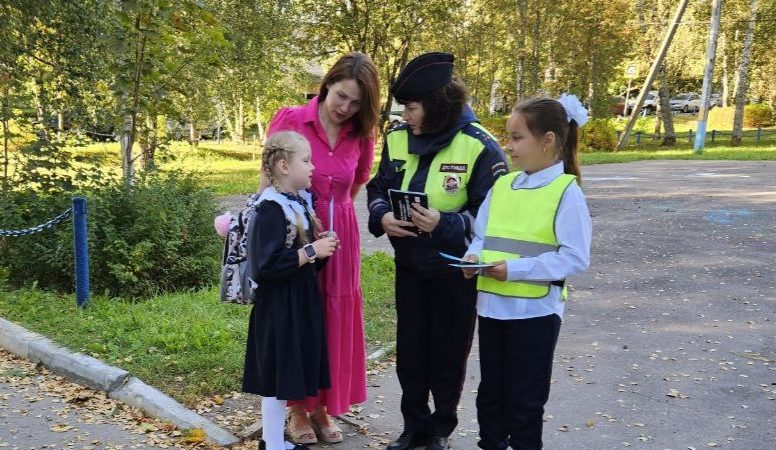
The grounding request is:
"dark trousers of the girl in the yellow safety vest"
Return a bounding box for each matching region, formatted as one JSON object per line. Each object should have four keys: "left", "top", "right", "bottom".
{"left": 477, "top": 314, "right": 561, "bottom": 450}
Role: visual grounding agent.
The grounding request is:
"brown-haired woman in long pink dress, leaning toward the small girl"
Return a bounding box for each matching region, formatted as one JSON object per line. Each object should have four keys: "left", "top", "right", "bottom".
{"left": 268, "top": 52, "right": 379, "bottom": 444}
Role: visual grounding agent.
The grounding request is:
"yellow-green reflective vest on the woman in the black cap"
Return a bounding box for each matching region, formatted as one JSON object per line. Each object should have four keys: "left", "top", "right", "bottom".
{"left": 386, "top": 123, "right": 495, "bottom": 212}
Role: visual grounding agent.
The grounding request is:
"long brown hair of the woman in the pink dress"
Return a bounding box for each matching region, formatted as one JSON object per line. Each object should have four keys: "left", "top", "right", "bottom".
{"left": 318, "top": 52, "right": 380, "bottom": 137}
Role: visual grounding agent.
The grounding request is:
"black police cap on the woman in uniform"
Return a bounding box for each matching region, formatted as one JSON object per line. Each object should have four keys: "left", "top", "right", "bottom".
{"left": 391, "top": 52, "right": 455, "bottom": 103}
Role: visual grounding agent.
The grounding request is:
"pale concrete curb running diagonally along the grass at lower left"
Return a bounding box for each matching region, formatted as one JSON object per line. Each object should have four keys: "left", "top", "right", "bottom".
{"left": 0, "top": 317, "right": 240, "bottom": 447}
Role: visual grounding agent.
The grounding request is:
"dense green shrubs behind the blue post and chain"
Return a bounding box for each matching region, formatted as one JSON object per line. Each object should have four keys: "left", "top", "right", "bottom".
{"left": 0, "top": 173, "right": 221, "bottom": 297}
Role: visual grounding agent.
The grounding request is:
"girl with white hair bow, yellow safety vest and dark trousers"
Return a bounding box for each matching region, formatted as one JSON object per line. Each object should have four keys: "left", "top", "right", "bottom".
{"left": 463, "top": 95, "right": 591, "bottom": 450}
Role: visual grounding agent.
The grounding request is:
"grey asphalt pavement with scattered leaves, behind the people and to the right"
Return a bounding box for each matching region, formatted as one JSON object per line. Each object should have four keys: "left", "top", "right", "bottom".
{"left": 348, "top": 161, "right": 776, "bottom": 450}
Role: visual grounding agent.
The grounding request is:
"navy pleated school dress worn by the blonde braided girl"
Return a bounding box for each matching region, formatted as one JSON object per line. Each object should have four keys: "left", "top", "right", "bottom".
{"left": 242, "top": 194, "right": 331, "bottom": 400}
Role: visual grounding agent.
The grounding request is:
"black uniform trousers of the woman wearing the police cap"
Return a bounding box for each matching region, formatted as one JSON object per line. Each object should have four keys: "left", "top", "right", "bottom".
{"left": 396, "top": 264, "right": 477, "bottom": 436}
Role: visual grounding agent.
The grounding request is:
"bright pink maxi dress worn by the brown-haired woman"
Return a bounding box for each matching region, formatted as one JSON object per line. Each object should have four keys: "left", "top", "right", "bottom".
{"left": 269, "top": 97, "right": 375, "bottom": 416}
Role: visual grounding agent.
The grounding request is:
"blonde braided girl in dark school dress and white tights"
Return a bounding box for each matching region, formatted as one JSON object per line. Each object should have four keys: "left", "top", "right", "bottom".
{"left": 242, "top": 131, "right": 338, "bottom": 450}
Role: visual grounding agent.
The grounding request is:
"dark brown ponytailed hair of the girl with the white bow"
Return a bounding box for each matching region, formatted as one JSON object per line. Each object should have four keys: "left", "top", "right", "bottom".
{"left": 512, "top": 98, "right": 582, "bottom": 184}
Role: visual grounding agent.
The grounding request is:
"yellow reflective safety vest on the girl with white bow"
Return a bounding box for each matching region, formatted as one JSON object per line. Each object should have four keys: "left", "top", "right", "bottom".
{"left": 477, "top": 172, "right": 576, "bottom": 300}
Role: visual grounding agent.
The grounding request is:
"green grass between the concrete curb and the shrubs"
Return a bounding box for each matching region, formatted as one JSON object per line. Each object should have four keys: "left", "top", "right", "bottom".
{"left": 0, "top": 253, "right": 395, "bottom": 405}
